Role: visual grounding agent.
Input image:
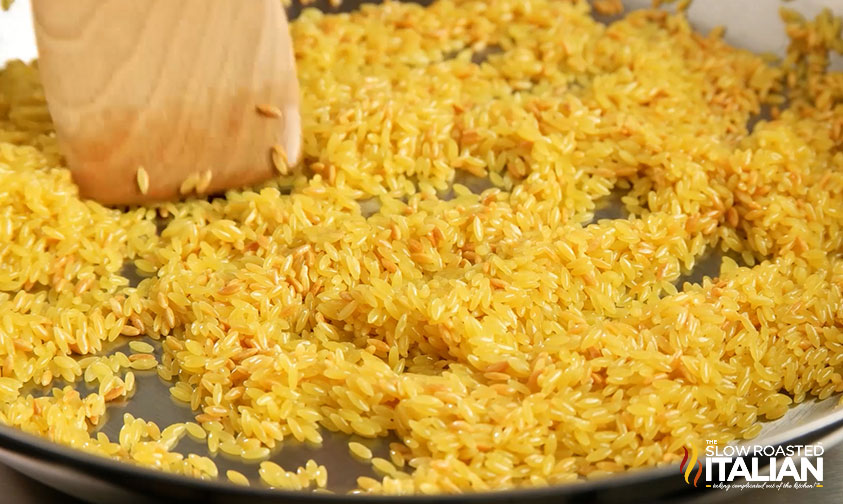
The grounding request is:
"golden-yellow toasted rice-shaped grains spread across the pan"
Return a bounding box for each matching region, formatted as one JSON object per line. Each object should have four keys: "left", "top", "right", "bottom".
{"left": 0, "top": 0, "right": 843, "bottom": 494}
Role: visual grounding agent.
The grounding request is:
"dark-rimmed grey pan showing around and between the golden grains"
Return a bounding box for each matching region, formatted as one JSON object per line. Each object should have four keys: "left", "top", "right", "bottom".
{"left": 0, "top": 0, "right": 843, "bottom": 503}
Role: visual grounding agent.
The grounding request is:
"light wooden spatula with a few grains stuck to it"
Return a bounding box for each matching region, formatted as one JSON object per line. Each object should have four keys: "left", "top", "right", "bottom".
{"left": 32, "top": 0, "right": 301, "bottom": 204}
